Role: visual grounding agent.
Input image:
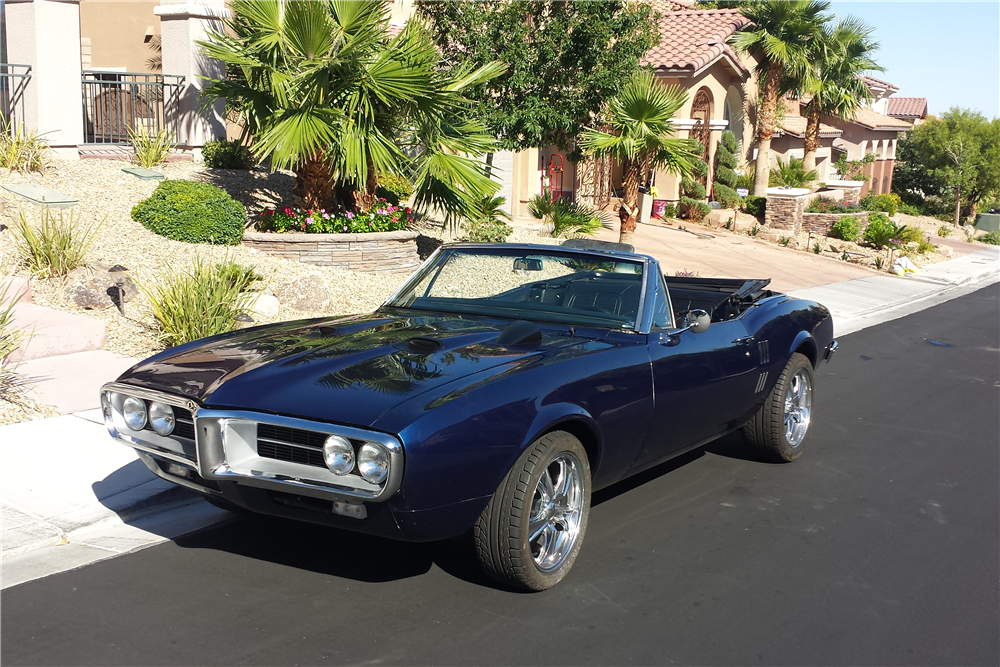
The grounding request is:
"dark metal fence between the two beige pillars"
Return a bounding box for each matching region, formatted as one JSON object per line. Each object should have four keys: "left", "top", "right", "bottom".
{"left": 83, "top": 70, "right": 184, "bottom": 144}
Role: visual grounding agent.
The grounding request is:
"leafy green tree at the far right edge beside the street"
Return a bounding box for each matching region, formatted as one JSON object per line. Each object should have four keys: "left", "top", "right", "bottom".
{"left": 893, "top": 107, "right": 1000, "bottom": 225}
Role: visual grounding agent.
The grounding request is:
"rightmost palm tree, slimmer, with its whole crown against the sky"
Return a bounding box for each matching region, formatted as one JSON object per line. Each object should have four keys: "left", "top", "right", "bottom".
{"left": 802, "top": 16, "right": 883, "bottom": 171}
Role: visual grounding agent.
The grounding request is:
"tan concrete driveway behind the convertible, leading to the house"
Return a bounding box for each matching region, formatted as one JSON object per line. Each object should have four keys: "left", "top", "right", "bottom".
{"left": 595, "top": 223, "right": 879, "bottom": 292}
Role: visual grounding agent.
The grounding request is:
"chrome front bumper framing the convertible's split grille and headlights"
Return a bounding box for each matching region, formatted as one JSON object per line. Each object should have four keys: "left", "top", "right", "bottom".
{"left": 101, "top": 382, "right": 403, "bottom": 503}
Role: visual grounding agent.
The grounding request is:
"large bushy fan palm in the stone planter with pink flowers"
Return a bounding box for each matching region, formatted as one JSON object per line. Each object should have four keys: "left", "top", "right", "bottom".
{"left": 200, "top": 0, "right": 503, "bottom": 216}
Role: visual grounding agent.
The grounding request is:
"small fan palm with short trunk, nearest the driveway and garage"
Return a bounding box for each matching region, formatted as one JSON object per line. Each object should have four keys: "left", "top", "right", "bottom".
{"left": 580, "top": 71, "right": 699, "bottom": 243}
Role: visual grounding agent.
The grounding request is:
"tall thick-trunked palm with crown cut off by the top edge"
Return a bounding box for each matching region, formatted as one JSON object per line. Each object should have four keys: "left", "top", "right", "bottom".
{"left": 729, "top": 0, "right": 830, "bottom": 197}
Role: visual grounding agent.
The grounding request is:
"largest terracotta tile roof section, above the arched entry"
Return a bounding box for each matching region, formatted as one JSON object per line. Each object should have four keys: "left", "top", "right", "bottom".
{"left": 642, "top": 9, "right": 750, "bottom": 77}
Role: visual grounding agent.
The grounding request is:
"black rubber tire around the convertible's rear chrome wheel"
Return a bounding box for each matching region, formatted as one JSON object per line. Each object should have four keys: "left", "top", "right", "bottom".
{"left": 743, "top": 352, "right": 815, "bottom": 462}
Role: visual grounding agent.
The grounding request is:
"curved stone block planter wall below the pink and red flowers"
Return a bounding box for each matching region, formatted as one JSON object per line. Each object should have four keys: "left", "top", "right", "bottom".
{"left": 243, "top": 231, "right": 420, "bottom": 273}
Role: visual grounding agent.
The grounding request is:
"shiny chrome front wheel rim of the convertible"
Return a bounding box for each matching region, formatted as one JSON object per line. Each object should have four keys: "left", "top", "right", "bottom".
{"left": 528, "top": 452, "right": 584, "bottom": 572}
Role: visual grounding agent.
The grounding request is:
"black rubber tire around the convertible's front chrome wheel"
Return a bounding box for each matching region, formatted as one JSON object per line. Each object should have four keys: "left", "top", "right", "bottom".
{"left": 473, "top": 431, "right": 591, "bottom": 591}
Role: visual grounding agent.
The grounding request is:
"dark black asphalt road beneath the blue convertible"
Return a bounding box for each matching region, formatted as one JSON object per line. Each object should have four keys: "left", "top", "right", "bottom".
{"left": 0, "top": 286, "right": 1000, "bottom": 665}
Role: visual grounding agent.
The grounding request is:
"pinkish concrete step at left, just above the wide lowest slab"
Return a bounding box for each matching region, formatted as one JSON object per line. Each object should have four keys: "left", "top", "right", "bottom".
{"left": 10, "top": 303, "right": 106, "bottom": 362}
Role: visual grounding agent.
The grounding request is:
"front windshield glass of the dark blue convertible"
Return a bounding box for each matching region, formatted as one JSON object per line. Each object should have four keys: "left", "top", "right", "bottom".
{"left": 386, "top": 247, "right": 643, "bottom": 329}
